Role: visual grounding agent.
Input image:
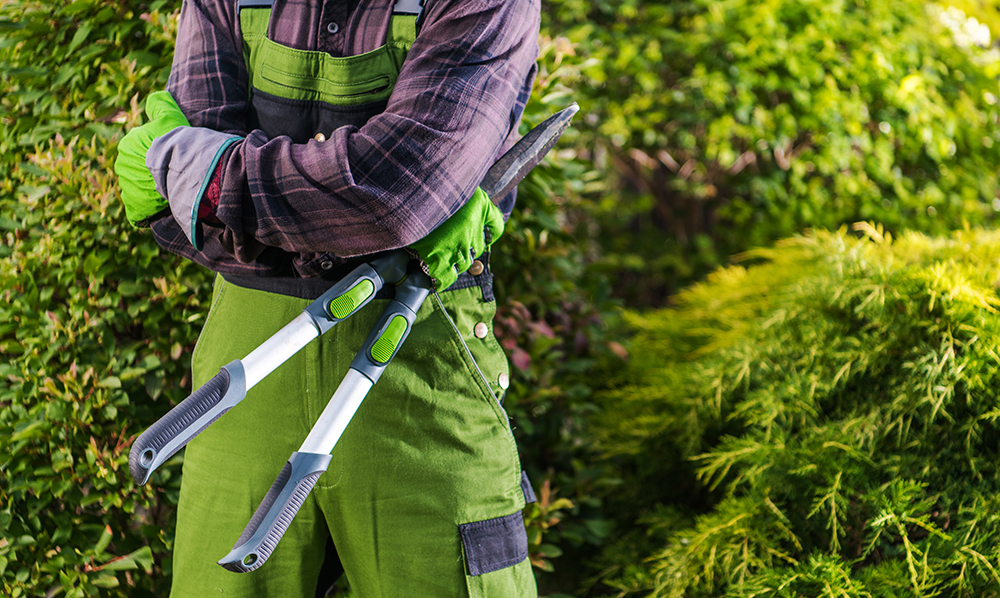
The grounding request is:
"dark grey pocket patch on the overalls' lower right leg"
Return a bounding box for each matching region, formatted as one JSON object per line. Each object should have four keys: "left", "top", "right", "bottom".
{"left": 458, "top": 511, "right": 528, "bottom": 575}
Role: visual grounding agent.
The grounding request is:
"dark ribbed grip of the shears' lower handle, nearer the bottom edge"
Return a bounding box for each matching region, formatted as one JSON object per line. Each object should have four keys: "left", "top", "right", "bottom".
{"left": 219, "top": 452, "right": 330, "bottom": 573}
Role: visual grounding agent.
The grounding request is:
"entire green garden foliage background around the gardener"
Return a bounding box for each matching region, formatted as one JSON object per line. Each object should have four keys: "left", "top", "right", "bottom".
{"left": 0, "top": 0, "right": 1000, "bottom": 598}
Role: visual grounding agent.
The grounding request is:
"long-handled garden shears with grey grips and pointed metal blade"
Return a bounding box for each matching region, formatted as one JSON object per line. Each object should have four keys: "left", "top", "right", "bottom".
{"left": 129, "top": 103, "right": 579, "bottom": 573}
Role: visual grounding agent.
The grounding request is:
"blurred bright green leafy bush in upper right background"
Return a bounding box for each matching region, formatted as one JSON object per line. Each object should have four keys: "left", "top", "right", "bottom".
{"left": 546, "top": 0, "right": 1000, "bottom": 306}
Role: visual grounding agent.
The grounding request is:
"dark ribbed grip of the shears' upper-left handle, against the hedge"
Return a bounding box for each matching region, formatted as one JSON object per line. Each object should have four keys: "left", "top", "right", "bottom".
{"left": 128, "top": 366, "right": 242, "bottom": 484}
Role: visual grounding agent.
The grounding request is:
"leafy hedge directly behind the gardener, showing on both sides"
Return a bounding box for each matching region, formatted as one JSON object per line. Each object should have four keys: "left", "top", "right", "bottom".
{"left": 0, "top": 0, "right": 620, "bottom": 598}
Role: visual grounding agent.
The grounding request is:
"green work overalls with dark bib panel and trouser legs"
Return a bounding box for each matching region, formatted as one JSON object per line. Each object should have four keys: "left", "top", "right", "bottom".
{"left": 171, "top": 0, "right": 536, "bottom": 598}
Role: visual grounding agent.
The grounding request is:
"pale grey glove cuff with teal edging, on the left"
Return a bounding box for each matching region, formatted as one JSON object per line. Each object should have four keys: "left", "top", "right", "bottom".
{"left": 146, "top": 127, "right": 243, "bottom": 251}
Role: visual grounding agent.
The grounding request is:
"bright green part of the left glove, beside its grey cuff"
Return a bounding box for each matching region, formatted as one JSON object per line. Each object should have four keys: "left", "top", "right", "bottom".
{"left": 115, "top": 91, "right": 190, "bottom": 224}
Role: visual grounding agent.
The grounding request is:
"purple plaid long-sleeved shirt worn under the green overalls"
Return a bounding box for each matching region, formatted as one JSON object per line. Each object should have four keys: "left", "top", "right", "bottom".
{"left": 153, "top": 0, "right": 540, "bottom": 277}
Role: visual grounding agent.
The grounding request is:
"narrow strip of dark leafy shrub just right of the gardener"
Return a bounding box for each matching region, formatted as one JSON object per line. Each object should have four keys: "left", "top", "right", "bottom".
{"left": 491, "top": 37, "right": 624, "bottom": 593}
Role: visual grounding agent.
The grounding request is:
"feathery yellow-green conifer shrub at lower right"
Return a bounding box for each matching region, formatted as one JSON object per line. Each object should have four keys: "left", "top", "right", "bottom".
{"left": 595, "top": 225, "right": 1000, "bottom": 598}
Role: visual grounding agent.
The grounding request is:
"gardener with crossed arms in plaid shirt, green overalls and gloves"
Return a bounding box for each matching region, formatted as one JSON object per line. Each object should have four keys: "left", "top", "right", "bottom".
{"left": 115, "top": 0, "right": 540, "bottom": 598}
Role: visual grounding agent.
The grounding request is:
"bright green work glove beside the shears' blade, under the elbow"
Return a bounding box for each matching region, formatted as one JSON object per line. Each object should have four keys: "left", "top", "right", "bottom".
{"left": 410, "top": 187, "right": 503, "bottom": 291}
